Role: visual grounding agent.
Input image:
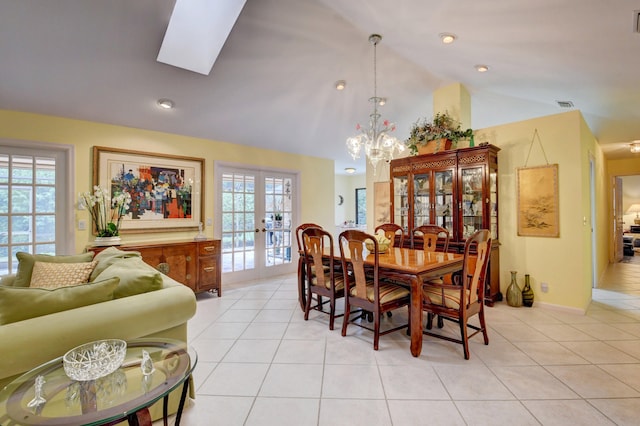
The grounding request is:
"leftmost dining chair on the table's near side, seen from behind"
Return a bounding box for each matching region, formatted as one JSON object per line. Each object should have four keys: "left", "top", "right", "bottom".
{"left": 302, "top": 227, "right": 345, "bottom": 330}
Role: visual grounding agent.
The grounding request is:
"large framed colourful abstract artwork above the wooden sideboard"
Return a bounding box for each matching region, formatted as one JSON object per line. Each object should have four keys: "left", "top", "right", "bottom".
{"left": 93, "top": 146, "right": 204, "bottom": 233}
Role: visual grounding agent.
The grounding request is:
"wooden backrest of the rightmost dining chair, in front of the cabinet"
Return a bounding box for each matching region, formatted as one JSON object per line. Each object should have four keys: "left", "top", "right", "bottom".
{"left": 462, "top": 229, "right": 491, "bottom": 306}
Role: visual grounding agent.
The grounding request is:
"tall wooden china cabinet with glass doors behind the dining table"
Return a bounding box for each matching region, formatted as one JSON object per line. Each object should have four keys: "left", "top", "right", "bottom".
{"left": 390, "top": 144, "right": 502, "bottom": 304}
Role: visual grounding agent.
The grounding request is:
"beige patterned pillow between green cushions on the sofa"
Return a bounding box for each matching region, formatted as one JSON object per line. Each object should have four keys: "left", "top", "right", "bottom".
{"left": 29, "top": 260, "right": 98, "bottom": 290}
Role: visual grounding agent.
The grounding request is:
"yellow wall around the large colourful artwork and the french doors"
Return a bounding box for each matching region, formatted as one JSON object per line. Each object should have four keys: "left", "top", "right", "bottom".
{"left": 0, "top": 110, "right": 335, "bottom": 252}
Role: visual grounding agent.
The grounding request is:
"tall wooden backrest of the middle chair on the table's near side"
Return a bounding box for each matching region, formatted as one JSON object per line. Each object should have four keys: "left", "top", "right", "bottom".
{"left": 338, "top": 229, "right": 379, "bottom": 303}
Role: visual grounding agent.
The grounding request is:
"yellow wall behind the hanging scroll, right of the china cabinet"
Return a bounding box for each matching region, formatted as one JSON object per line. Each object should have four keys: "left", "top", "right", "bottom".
{"left": 367, "top": 111, "right": 608, "bottom": 311}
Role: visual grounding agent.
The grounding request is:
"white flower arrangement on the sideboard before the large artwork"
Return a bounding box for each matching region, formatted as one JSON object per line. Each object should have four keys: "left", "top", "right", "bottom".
{"left": 80, "top": 186, "right": 131, "bottom": 237}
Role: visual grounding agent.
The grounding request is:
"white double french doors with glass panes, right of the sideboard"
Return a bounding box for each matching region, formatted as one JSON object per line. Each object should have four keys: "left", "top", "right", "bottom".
{"left": 216, "top": 166, "right": 297, "bottom": 282}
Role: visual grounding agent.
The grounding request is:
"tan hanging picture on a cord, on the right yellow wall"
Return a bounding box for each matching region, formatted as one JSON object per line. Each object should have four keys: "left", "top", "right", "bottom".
{"left": 517, "top": 164, "right": 560, "bottom": 237}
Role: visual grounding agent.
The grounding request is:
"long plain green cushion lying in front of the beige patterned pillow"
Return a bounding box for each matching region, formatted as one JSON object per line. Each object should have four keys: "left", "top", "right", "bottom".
{"left": 0, "top": 277, "right": 120, "bottom": 325}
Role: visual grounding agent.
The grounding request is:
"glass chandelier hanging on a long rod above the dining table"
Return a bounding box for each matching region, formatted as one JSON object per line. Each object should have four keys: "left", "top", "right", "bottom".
{"left": 347, "top": 34, "right": 405, "bottom": 172}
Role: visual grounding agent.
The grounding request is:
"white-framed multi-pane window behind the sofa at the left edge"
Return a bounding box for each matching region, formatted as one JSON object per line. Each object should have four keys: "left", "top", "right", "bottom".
{"left": 0, "top": 140, "right": 75, "bottom": 275}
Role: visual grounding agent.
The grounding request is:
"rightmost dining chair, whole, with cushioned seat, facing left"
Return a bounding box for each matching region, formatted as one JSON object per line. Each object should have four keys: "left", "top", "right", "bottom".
{"left": 422, "top": 229, "right": 491, "bottom": 359}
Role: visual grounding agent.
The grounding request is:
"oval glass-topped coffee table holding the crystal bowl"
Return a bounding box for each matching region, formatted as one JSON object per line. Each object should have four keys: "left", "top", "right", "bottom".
{"left": 0, "top": 339, "right": 198, "bottom": 426}
